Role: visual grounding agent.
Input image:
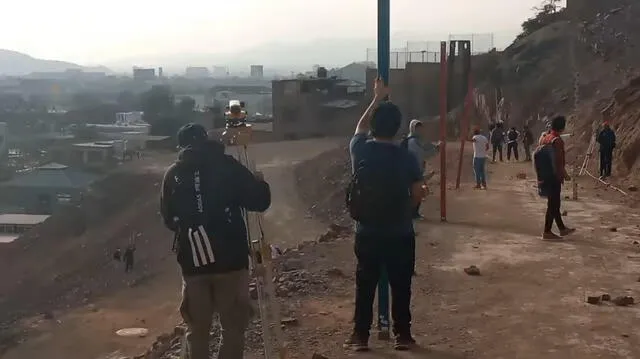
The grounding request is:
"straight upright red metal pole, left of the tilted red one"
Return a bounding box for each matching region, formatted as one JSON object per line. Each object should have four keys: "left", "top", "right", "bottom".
{"left": 440, "top": 41, "right": 449, "bottom": 222}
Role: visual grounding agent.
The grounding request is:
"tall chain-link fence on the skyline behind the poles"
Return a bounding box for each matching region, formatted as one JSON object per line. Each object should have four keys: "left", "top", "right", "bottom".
{"left": 367, "top": 33, "right": 494, "bottom": 69}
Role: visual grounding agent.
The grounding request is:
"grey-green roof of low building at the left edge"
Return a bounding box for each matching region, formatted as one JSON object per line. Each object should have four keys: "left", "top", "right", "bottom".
{"left": 0, "top": 167, "right": 98, "bottom": 189}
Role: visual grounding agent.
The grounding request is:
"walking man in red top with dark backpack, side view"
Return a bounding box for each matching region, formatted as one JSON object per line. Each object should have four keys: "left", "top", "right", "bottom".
{"left": 534, "top": 116, "right": 575, "bottom": 240}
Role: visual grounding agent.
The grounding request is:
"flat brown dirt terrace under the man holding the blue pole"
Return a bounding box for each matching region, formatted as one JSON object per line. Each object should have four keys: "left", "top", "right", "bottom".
{"left": 276, "top": 156, "right": 640, "bottom": 359}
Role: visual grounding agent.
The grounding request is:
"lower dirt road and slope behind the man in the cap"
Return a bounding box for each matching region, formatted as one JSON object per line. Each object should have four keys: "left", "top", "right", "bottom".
{"left": 1, "top": 139, "right": 337, "bottom": 359}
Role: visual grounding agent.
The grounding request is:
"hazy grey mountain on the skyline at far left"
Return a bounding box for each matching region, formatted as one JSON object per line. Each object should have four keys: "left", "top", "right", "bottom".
{"left": 0, "top": 49, "right": 111, "bottom": 76}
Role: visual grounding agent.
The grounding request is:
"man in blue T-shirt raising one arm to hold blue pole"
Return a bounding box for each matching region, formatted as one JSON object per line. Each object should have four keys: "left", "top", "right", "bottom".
{"left": 345, "top": 79, "right": 423, "bottom": 351}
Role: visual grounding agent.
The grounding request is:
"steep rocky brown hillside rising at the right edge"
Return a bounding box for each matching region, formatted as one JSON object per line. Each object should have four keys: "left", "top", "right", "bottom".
{"left": 476, "top": 0, "right": 640, "bottom": 193}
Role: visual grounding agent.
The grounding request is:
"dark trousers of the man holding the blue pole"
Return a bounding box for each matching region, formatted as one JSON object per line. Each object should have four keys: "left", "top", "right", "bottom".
{"left": 354, "top": 234, "right": 416, "bottom": 339}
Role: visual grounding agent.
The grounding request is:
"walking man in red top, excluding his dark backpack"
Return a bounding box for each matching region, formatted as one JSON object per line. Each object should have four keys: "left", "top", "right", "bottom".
{"left": 540, "top": 116, "right": 575, "bottom": 239}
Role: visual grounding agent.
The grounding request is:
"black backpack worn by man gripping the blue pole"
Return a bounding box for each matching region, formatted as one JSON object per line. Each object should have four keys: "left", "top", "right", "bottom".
{"left": 345, "top": 148, "right": 411, "bottom": 225}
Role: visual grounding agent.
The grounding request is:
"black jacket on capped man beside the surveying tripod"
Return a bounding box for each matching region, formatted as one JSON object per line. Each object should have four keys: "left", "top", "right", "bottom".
{"left": 160, "top": 142, "right": 271, "bottom": 276}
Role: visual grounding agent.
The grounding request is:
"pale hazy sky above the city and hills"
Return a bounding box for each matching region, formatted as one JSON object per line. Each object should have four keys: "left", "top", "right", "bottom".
{"left": 0, "top": 0, "right": 560, "bottom": 64}
